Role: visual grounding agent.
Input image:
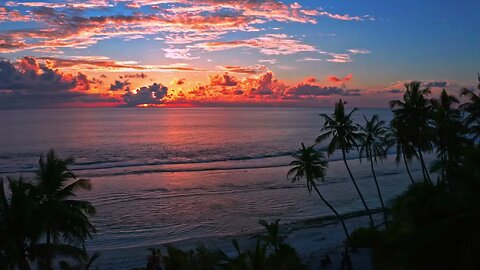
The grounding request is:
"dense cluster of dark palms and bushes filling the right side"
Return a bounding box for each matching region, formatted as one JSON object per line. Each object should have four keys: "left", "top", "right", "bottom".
{"left": 291, "top": 74, "right": 480, "bottom": 269}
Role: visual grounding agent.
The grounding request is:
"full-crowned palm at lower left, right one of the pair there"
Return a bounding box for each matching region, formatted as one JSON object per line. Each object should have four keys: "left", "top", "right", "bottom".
{"left": 35, "top": 150, "right": 95, "bottom": 267}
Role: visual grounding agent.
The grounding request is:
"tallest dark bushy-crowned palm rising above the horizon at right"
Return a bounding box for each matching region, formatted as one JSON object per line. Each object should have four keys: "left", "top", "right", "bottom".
{"left": 390, "top": 82, "right": 432, "bottom": 183}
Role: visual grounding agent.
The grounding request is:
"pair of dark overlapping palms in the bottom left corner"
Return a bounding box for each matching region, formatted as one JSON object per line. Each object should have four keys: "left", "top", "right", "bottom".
{"left": 0, "top": 150, "right": 95, "bottom": 270}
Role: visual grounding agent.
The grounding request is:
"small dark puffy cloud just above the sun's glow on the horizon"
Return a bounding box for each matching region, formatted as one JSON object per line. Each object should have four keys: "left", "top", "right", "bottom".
{"left": 123, "top": 83, "right": 168, "bottom": 107}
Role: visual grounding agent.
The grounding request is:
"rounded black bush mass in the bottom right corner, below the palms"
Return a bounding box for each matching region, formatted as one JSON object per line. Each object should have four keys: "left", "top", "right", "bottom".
{"left": 374, "top": 183, "right": 480, "bottom": 269}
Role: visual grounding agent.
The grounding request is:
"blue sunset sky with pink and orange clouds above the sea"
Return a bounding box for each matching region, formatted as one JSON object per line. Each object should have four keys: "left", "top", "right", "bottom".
{"left": 0, "top": 0, "right": 480, "bottom": 109}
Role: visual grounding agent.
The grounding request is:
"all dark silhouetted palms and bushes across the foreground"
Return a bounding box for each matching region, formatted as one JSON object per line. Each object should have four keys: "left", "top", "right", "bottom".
{"left": 0, "top": 76, "right": 480, "bottom": 270}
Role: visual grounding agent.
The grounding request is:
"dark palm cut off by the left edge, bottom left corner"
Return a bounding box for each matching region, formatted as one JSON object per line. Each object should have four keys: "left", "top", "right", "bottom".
{"left": 0, "top": 178, "right": 38, "bottom": 270}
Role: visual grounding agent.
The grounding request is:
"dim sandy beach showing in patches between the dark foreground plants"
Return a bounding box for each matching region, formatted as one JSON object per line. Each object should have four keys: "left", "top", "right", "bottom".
{"left": 90, "top": 214, "right": 381, "bottom": 270}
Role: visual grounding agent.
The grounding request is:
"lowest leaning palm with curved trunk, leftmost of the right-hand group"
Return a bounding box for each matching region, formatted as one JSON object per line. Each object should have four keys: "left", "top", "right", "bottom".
{"left": 287, "top": 143, "right": 350, "bottom": 240}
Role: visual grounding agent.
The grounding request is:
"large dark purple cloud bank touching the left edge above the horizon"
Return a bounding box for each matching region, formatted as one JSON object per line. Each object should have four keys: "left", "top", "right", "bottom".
{"left": 0, "top": 57, "right": 113, "bottom": 108}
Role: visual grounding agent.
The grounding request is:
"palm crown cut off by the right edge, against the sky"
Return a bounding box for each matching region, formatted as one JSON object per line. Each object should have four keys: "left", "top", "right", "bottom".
{"left": 460, "top": 74, "right": 480, "bottom": 139}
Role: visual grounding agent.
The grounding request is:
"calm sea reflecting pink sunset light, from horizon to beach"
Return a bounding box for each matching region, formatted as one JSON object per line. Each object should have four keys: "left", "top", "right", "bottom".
{"left": 0, "top": 108, "right": 418, "bottom": 268}
